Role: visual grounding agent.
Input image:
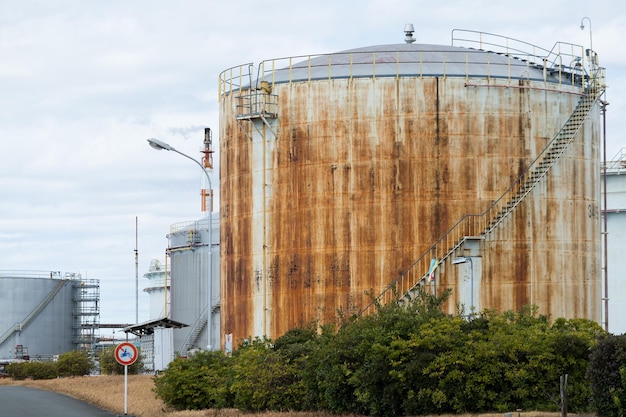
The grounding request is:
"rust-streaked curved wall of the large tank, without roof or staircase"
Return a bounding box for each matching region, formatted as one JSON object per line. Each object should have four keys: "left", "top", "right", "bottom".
{"left": 220, "top": 41, "right": 600, "bottom": 342}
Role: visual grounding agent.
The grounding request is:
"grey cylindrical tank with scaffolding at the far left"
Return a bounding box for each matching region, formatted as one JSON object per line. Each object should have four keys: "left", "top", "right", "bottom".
{"left": 0, "top": 271, "right": 100, "bottom": 360}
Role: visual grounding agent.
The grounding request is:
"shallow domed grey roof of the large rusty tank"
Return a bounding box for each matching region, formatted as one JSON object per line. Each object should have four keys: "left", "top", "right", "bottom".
{"left": 264, "top": 43, "right": 559, "bottom": 83}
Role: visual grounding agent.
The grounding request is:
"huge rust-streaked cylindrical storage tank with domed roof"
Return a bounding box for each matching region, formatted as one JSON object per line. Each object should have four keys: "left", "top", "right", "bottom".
{"left": 220, "top": 31, "right": 604, "bottom": 343}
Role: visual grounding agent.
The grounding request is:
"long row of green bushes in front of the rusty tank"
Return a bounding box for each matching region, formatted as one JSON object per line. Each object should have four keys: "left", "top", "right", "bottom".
{"left": 150, "top": 292, "right": 600, "bottom": 417}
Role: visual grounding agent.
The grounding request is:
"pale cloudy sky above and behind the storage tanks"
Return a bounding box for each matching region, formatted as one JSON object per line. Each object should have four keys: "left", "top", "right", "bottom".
{"left": 0, "top": 0, "right": 626, "bottom": 332}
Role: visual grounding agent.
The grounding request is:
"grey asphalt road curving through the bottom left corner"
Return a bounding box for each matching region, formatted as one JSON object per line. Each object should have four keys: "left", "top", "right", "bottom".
{"left": 0, "top": 386, "right": 117, "bottom": 417}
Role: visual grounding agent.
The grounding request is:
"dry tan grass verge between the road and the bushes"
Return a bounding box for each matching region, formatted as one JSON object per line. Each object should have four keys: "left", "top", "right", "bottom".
{"left": 0, "top": 375, "right": 588, "bottom": 417}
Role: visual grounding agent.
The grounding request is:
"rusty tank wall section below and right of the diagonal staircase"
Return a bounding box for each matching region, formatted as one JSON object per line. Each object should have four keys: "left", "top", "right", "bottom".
{"left": 481, "top": 115, "right": 602, "bottom": 316}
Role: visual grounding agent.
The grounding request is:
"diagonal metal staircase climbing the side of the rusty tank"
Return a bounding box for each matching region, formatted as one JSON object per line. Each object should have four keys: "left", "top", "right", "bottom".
{"left": 358, "top": 84, "right": 604, "bottom": 316}
